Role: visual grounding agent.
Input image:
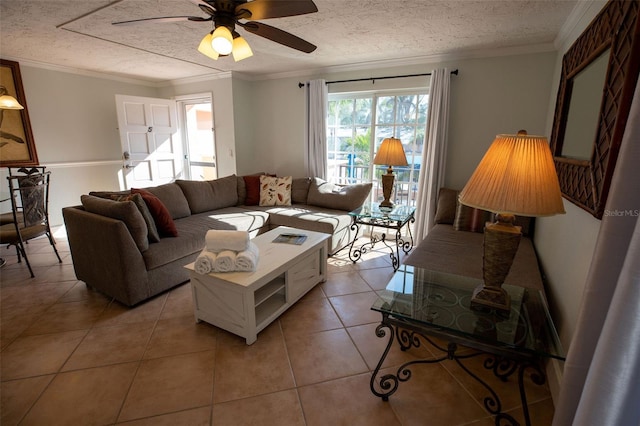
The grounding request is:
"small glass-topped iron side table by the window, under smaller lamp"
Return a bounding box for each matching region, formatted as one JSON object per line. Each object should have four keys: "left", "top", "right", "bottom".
{"left": 349, "top": 203, "right": 416, "bottom": 271}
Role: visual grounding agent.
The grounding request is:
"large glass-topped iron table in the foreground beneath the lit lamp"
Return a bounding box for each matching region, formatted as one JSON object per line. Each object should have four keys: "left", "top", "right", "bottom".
{"left": 371, "top": 265, "right": 565, "bottom": 425}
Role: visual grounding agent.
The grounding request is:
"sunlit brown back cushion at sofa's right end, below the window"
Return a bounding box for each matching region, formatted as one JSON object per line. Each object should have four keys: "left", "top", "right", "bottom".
{"left": 307, "top": 178, "right": 372, "bottom": 211}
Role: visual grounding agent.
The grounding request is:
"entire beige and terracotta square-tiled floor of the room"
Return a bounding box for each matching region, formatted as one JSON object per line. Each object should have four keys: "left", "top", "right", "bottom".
{"left": 0, "top": 228, "right": 554, "bottom": 426}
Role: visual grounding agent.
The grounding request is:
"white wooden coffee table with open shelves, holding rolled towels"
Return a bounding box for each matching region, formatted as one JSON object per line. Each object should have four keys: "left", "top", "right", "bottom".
{"left": 185, "top": 226, "right": 330, "bottom": 345}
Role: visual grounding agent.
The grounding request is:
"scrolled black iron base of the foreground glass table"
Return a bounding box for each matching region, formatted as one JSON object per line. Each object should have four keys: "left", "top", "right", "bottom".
{"left": 370, "top": 314, "right": 546, "bottom": 426}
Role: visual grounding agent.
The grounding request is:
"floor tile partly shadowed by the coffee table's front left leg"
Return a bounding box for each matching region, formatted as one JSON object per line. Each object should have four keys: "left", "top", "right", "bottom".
{"left": 144, "top": 316, "right": 218, "bottom": 359}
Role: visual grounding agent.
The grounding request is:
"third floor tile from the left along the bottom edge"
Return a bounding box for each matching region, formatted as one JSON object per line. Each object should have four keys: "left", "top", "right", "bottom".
{"left": 118, "top": 351, "right": 215, "bottom": 422}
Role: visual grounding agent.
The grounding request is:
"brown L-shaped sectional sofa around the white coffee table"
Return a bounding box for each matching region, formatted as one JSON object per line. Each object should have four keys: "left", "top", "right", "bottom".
{"left": 62, "top": 175, "right": 371, "bottom": 306}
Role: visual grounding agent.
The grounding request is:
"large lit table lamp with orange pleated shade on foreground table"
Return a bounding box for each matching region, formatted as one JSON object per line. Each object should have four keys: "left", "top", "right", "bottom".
{"left": 459, "top": 130, "right": 564, "bottom": 311}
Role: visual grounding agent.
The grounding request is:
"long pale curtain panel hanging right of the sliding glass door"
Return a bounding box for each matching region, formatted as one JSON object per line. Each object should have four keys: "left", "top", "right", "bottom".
{"left": 414, "top": 68, "right": 451, "bottom": 245}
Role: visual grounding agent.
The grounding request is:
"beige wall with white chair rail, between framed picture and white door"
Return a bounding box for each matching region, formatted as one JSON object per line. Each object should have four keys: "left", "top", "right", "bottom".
{"left": 0, "top": 64, "right": 157, "bottom": 225}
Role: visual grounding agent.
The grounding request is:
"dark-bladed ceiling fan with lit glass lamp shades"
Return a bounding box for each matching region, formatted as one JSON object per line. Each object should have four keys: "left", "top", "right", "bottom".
{"left": 113, "top": 0, "right": 318, "bottom": 62}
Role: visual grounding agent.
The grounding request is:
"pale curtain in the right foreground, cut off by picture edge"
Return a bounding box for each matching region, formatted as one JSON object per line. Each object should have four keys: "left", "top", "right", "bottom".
{"left": 553, "top": 79, "right": 640, "bottom": 426}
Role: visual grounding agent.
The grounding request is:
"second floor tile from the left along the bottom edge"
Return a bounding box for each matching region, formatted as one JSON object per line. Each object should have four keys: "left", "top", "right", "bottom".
{"left": 21, "top": 363, "right": 138, "bottom": 426}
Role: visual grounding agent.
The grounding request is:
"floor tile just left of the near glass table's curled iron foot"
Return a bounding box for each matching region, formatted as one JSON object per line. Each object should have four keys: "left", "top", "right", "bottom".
{"left": 286, "top": 329, "right": 368, "bottom": 386}
